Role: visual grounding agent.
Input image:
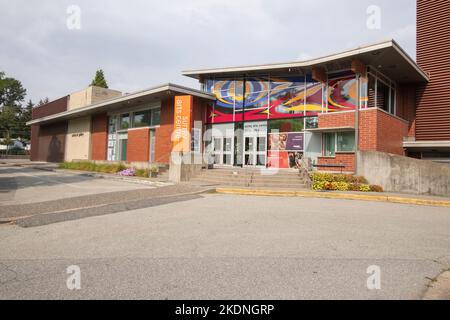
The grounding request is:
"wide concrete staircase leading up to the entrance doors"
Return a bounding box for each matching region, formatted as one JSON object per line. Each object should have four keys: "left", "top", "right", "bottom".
{"left": 191, "top": 168, "right": 311, "bottom": 190}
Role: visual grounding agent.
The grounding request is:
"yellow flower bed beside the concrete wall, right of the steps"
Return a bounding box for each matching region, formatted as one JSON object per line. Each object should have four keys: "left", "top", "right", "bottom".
{"left": 311, "top": 172, "right": 383, "bottom": 192}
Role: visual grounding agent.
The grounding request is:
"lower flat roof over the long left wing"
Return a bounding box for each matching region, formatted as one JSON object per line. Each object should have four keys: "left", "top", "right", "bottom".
{"left": 27, "top": 83, "right": 216, "bottom": 125}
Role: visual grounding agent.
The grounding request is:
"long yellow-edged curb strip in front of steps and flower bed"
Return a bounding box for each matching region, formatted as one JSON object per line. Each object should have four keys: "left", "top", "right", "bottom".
{"left": 216, "top": 187, "right": 450, "bottom": 207}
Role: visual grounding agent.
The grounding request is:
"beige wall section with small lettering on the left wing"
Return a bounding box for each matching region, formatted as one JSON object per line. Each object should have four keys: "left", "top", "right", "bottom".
{"left": 64, "top": 117, "right": 91, "bottom": 161}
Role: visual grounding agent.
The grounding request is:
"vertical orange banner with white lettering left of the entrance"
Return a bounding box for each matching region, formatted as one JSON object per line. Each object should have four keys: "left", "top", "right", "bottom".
{"left": 172, "top": 96, "right": 193, "bottom": 152}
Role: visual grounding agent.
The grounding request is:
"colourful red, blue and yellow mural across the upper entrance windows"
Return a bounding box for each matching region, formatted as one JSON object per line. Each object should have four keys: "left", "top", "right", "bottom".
{"left": 207, "top": 72, "right": 367, "bottom": 123}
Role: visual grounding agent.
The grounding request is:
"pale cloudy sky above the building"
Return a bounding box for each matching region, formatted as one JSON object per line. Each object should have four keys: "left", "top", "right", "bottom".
{"left": 0, "top": 0, "right": 416, "bottom": 102}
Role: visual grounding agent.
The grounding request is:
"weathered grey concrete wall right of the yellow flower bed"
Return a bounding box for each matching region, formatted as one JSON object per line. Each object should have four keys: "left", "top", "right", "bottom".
{"left": 357, "top": 151, "right": 450, "bottom": 197}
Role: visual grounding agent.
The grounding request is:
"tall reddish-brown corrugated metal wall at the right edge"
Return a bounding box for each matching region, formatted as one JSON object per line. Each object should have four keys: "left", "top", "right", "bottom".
{"left": 416, "top": 0, "right": 450, "bottom": 140}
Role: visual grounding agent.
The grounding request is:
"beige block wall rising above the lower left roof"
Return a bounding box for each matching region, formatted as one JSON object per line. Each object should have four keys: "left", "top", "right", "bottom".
{"left": 67, "top": 86, "right": 122, "bottom": 110}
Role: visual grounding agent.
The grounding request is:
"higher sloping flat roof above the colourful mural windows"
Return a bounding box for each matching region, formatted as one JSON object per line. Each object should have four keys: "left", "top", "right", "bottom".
{"left": 182, "top": 39, "right": 429, "bottom": 82}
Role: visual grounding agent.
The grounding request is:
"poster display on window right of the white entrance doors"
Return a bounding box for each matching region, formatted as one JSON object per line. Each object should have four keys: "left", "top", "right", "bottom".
{"left": 268, "top": 132, "right": 305, "bottom": 169}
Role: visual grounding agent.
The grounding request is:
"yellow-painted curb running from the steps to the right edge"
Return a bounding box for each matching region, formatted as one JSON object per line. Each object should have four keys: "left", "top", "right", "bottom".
{"left": 216, "top": 188, "right": 450, "bottom": 207}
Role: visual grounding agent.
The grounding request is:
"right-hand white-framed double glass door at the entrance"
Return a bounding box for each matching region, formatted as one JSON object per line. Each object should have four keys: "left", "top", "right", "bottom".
{"left": 244, "top": 133, "right": 267, "bottom": 167}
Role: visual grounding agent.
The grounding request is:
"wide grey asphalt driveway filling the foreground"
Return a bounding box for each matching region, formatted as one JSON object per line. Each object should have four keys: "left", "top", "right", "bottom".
{"left": 0, "top": 195, "right": 450, "bottom": 299}
